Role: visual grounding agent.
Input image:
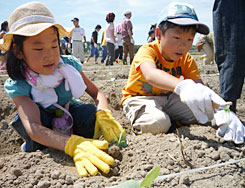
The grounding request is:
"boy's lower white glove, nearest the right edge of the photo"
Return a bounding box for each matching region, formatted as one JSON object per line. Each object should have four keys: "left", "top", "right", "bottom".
{"left": 214, "top": 110, "right": 245, "bottom": 144}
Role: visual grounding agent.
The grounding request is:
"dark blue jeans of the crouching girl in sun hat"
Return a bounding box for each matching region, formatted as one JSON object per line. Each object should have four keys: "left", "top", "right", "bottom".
{"left": 11, "top": 104, "right": 97, "bottom": 152}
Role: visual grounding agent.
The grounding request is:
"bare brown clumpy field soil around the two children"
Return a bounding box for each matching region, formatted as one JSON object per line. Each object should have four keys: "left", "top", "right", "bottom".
{"left": 0, "top": 56, "right": 245, "bottom": 188}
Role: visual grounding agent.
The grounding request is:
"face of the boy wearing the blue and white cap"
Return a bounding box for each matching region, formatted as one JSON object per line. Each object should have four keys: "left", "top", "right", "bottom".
{"left": 156, "top": 26, "right": 196, "bottom": 61}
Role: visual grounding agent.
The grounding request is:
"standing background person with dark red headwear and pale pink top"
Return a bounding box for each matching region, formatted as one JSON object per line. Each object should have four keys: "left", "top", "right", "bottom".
{"left": 105, "top": 12, "right": 116, "bottom": 65}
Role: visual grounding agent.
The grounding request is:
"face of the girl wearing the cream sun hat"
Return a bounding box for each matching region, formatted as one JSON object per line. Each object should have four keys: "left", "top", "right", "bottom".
{"left": 23, "top": 27, "right": 60, "bottom": 75}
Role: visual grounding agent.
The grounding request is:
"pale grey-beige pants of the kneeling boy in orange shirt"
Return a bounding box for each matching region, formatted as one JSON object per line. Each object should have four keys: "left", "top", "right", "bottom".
{"left": 123, "top": 93, "right": 197, "bottom": 134}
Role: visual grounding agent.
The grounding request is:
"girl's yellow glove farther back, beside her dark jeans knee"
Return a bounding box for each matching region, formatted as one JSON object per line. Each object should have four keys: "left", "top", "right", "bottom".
{"left": 94, "top": 110, "right": 123, "bottom": 142}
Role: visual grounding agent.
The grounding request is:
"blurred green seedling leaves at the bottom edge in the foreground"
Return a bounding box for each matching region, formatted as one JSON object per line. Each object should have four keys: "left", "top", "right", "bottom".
{"left": 113, "top": 166, "right": 160, "bottom": 188}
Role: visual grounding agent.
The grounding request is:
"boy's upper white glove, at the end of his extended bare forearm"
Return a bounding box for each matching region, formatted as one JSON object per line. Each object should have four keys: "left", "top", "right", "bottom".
{"left": 174, "top": 79, "right": 231, "bottom": 124}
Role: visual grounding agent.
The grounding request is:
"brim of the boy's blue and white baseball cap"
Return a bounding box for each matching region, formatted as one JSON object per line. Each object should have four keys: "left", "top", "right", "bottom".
{"left": 167, "top": 18, "right": 209, "bottom": 35}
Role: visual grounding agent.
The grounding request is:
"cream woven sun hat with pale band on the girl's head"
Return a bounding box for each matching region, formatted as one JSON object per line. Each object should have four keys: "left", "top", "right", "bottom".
{"left": 0, "top": 1, "right": 69, "bottom": 51}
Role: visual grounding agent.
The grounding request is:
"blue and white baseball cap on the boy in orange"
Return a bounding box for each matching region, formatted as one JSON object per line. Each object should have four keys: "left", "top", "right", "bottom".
{"left": 157, "top": 2, "right": 209, "bottom": 35}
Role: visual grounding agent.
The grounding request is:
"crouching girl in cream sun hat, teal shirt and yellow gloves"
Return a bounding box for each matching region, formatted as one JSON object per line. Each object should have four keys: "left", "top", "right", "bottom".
{"left": 0, "top": 2, "right": 122, "bottom": 176}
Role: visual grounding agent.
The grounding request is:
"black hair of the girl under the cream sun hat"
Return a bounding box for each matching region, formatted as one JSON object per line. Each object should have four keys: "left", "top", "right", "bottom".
{"left": 6, "top": 26, "right": 60, "bottom": 80}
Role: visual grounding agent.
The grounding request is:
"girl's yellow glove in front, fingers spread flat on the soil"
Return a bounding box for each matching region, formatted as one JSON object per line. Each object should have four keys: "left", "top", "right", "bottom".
{"left": 65, "top": 135, "right": 114, "bottom": 176}
